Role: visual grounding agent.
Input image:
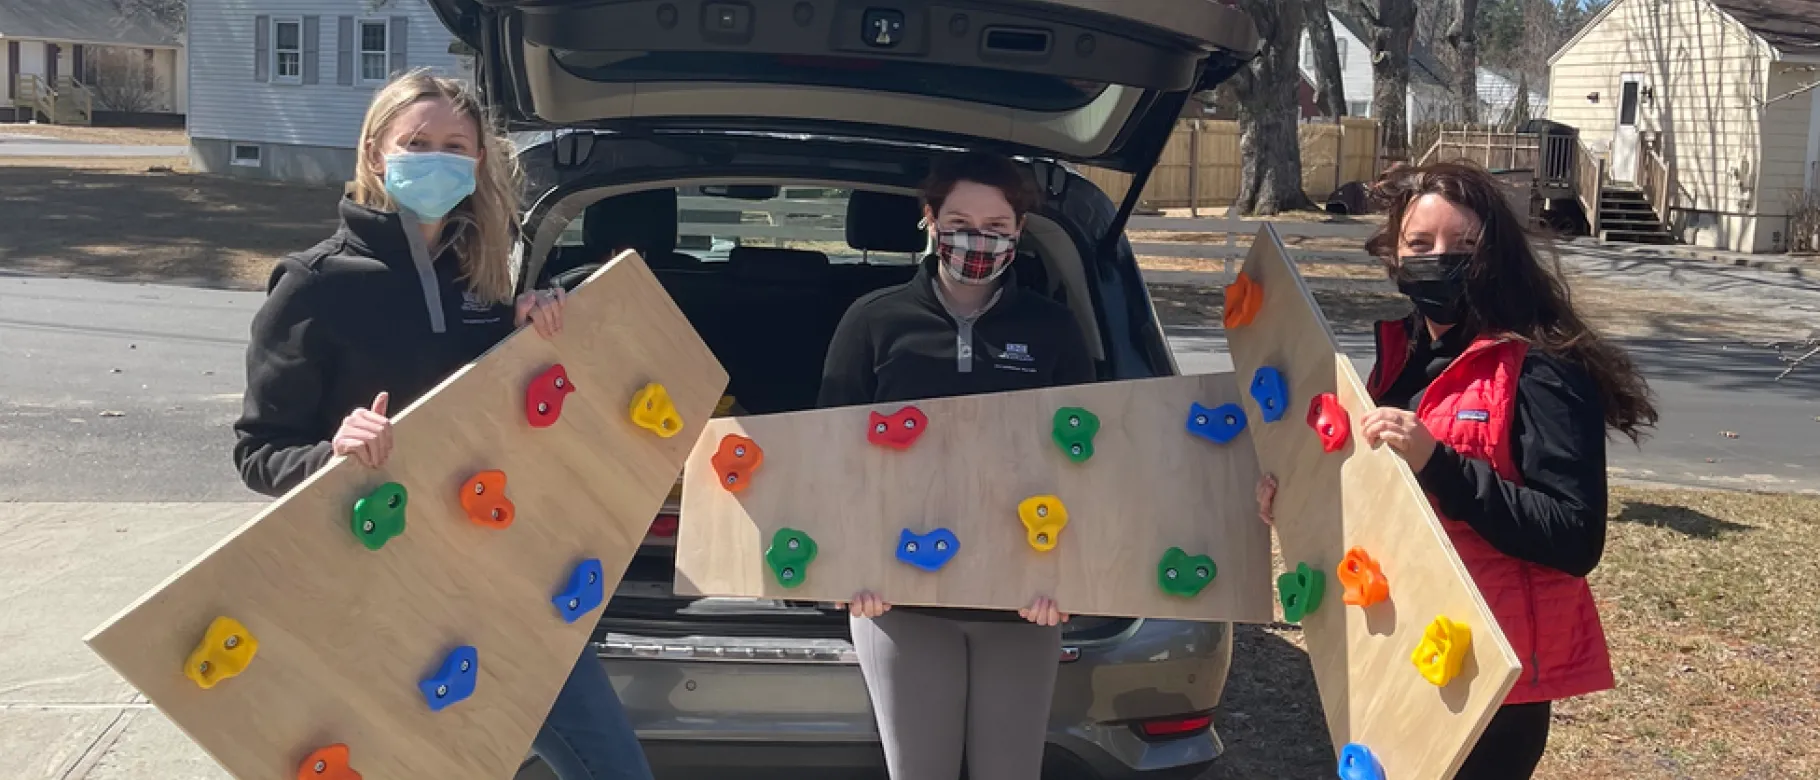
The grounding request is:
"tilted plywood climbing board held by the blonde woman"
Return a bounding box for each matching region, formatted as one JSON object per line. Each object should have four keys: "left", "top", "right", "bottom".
{"left": 87, "top": 253, "right": 728, "bottom": 780}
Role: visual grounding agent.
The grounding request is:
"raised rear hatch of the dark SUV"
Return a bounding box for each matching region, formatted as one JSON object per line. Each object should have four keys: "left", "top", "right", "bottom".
{"left": 430, "top": 0, "right": 1258, "bottom": 173}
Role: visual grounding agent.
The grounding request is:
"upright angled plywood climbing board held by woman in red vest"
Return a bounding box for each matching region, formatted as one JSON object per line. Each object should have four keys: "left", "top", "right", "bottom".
{"left": 1227, "top": 225, "right": 1522, "bottom": 770}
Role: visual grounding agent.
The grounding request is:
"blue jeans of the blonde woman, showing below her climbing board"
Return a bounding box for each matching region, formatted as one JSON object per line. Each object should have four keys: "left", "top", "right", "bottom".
{"left": 531, "top": 642, "right": 652, "bottom": 780}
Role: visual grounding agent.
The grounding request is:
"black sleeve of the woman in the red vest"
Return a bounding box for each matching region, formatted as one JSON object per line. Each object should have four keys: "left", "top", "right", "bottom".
{"left": 1418, "top": 355, "right": 1607, "bottom": 576}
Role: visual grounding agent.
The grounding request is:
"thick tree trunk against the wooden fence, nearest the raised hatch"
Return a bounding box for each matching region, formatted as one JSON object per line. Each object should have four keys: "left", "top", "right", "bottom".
{"left": 1232, "top": 0, "right": 1314, "bottom": 215}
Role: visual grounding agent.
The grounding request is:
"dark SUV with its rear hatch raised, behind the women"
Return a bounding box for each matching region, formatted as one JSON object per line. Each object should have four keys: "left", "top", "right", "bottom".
{"left": 431, "top": 0, "right": 1256, "bottom": 780}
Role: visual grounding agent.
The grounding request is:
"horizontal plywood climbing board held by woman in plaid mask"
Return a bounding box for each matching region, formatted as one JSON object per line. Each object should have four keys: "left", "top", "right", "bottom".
{"left": 675, "top": 375, "right": 1270, "bottom": 622}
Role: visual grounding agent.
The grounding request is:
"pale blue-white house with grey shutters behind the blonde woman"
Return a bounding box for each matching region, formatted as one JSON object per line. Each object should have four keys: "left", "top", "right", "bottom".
{"left": 189, "top": 0, "right": 473, "bottom": 184}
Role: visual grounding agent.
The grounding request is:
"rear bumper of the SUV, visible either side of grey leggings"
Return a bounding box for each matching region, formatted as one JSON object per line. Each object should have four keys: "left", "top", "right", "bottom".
{"left": 601, "top": 620, "right": 1232, "bottom": 780}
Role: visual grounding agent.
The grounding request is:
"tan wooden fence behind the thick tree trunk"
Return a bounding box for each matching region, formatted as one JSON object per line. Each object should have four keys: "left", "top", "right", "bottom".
{"left": 1081, "top": 116, "right": 1380, "bottom": 209}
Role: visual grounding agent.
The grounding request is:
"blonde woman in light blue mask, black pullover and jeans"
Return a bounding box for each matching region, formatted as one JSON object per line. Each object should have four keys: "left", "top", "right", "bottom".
{"left": 233, "top": 71, "right": 652, "bottom": 780}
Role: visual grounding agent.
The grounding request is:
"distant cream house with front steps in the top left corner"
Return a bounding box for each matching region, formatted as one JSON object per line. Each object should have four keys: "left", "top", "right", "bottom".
{"left": 0, "top": 0, "right": 189, "bottom": 124}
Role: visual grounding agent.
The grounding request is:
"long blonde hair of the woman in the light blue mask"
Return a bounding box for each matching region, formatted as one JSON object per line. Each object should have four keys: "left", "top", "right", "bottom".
{"left": 349, "top": 69, "right": 521, "bottom": 304}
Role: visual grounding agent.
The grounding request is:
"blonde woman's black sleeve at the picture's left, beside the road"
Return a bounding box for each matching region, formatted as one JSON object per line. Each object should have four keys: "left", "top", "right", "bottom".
{"left": 233, "top": 269, "right": 333, "bottom": 496}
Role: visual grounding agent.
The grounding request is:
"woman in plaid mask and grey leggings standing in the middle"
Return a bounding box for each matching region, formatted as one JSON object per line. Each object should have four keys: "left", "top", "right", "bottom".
{"left": 819, "top": 153, "right": 1096, "bottom": 780}
